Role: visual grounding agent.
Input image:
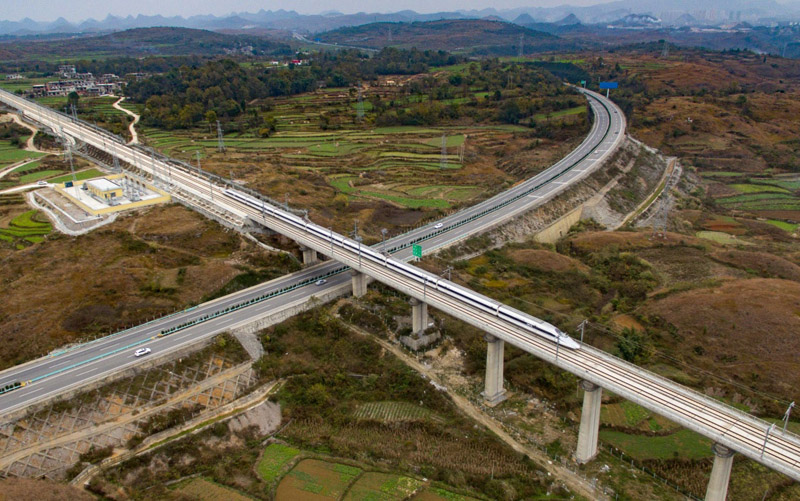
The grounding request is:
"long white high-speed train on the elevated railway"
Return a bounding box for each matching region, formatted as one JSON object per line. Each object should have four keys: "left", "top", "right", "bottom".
{"left": 225, "top": 189, "right": 580, "bottom": 350}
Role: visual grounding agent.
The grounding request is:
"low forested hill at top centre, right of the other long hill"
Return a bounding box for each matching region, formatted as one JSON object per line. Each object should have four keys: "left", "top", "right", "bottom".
{"left": 317, "top": 19, "right": 575, "bottom": 55}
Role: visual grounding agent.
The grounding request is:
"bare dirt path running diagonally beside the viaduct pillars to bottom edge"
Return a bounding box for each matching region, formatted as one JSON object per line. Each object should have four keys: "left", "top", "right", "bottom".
{"left": 348, "top": 324, "right": 607, "bottom": 500}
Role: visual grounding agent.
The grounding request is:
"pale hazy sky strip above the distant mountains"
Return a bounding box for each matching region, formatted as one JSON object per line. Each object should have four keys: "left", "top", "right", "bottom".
{"left": 0, "top": 0, "right": 610, "bottom": 22}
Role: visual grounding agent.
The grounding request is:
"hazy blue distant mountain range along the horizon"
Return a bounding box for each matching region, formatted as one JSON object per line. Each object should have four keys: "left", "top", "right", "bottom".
{"left": 0, "top": 0, "right": 800, "bottom": 36}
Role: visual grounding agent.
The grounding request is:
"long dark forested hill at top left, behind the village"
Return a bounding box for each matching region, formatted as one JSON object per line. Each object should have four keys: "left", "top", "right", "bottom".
{"left": 0, "top": 28, "right": 291, "bottom": 70}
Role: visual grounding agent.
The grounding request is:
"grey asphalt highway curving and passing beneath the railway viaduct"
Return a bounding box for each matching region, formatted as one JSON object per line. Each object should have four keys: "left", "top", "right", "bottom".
{"left": 0, "top": 88, "right": 625, "bottom": 414}
